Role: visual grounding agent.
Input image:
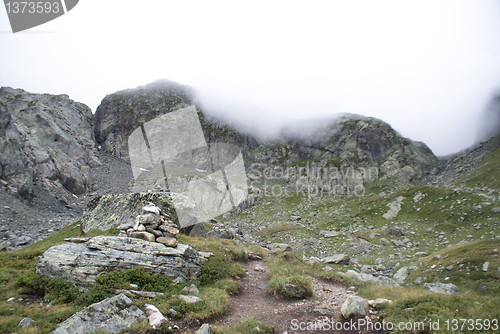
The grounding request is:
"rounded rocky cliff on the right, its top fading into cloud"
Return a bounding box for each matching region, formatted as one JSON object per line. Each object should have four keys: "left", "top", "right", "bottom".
{"left": 249, "top": 115, "right": 437, "bottom": 182}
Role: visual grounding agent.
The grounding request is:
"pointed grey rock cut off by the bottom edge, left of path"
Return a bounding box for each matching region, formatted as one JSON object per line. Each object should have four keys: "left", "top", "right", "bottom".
{"left": 51, "top": 294, "right": 146, "bottom": 334}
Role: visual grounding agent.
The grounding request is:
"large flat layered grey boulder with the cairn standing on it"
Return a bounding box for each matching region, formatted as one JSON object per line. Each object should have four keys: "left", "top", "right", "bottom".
{"left": 36, "top": 236, "right": 206, "bottom": 286}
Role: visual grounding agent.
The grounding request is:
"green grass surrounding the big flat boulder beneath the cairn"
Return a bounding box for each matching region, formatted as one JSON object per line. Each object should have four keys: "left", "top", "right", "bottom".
{"left": 0, "top": 222, "right": 252, "bottom": 334}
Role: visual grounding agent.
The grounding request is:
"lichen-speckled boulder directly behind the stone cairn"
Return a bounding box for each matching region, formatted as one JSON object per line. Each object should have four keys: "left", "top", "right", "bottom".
{"left": 81, "top": 193, "right": 177, "bottom": 233}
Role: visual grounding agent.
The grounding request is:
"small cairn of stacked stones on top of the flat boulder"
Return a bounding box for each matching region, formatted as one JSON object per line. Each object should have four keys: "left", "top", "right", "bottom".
{"left": 118, "top": 204, "right": 179, "bottom": 247}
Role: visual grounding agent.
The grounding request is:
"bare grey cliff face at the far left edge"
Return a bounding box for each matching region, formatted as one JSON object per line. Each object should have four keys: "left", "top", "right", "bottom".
{"left": 0, "top": 87, "right": 99, "bottom": 200}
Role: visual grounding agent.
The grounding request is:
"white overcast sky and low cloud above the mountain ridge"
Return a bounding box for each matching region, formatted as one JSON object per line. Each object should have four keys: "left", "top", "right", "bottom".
{"left": 0, "top": 0, "right": 500, "bottom": 155}
